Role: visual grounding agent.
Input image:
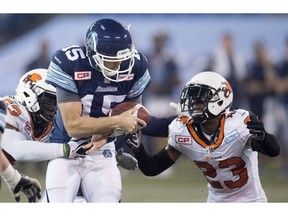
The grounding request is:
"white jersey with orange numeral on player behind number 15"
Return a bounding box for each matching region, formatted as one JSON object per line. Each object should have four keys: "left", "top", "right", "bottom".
{"left": 2, "top": 97, "right": 52, "bottom": 143}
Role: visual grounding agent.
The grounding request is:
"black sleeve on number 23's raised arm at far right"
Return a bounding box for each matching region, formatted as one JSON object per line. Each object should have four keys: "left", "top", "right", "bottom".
{"left": 251, "top": 132, "right": 280, "bottom": 157}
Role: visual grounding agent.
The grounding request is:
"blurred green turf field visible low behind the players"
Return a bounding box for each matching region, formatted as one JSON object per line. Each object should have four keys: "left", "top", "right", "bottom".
{"left": 0, "top": 158, "right": 288, "bottom": 203}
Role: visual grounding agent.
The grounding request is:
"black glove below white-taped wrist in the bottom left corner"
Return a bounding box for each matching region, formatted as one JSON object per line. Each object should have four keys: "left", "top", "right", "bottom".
{"left": 11, "top": 175, "right": 41, "bottom": 203}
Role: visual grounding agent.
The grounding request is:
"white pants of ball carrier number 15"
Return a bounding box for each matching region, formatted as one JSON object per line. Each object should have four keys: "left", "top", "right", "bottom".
{"left": 44, "top": 149, "right": 122, "bottom": 203}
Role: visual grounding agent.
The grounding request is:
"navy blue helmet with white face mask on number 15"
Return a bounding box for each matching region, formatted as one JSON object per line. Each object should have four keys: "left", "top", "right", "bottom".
{"left": 85, "top": 19, "right": 135, "bottom": 82}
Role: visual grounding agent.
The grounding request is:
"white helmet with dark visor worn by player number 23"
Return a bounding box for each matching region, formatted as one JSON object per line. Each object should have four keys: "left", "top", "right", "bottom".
{"left": 180, "top": 71, "right": 233, "bottom": 124}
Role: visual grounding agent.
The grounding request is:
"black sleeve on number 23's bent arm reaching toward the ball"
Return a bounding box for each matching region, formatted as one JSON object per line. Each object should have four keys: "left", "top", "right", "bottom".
{"left": 134, "top": 144, "right": 175, "bottom": 176}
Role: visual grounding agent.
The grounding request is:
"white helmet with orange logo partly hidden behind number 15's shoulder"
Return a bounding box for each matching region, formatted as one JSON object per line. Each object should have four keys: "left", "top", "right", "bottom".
{"left": 15, "top": 69, "right": 56, "bottom": 124}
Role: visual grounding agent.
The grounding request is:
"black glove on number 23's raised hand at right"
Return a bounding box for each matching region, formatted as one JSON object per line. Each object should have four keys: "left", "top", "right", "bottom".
{"left": 247, "top": 115, "right": 266, "bottom": 141}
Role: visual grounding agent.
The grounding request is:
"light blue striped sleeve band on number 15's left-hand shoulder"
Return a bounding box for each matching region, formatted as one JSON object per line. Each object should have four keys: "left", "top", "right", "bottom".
{"left": 46, "top": 62, "right": 78, "bottom": 93}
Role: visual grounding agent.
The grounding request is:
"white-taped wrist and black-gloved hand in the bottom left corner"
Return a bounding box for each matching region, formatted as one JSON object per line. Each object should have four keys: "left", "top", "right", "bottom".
{"left": 1, "top": 164, "right": 41, "bottom": 203}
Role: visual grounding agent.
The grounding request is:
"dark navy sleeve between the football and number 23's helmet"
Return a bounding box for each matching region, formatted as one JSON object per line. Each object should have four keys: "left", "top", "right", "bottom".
{"left": 141, "top": 115, "right": 178, "bottom": 137}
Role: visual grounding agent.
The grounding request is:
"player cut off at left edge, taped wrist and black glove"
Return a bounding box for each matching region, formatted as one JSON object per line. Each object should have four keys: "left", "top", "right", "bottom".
{"left": 0, "top": 101, "right": 41, "bottom": 202}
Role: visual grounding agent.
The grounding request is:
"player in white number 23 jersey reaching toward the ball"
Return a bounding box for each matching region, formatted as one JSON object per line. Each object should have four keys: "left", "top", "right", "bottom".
{"left": 126, "top": 71, "right": 280, "bottom": 202}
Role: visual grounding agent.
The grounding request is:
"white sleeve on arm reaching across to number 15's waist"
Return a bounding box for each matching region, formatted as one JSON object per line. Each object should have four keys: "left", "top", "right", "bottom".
{"left": 2, "top": 128, "right": 64, "bottom": 162}
